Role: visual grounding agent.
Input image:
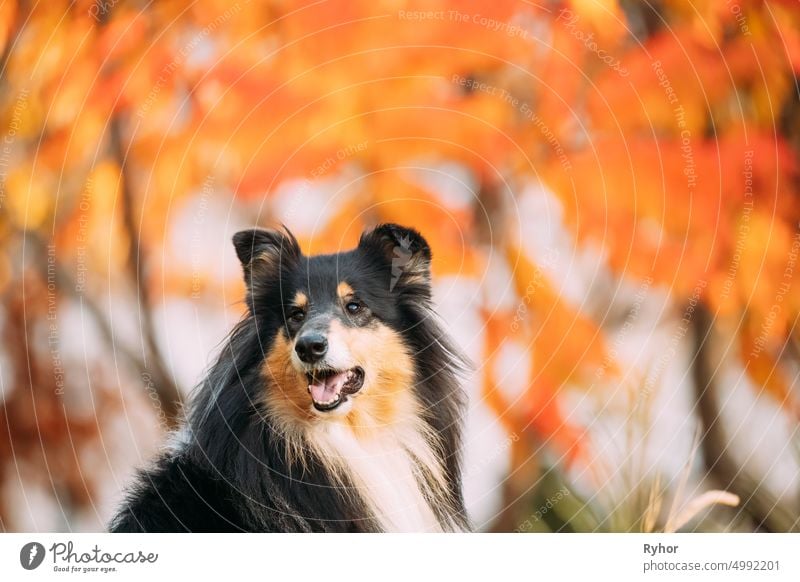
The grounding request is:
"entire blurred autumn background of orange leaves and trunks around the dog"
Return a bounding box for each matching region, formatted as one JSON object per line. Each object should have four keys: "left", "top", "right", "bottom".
{"left": 0, "top": 0, "right": 800, "bottom": 532}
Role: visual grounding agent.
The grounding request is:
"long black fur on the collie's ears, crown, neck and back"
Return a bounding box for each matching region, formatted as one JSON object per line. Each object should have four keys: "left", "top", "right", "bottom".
{"left": 109, "top": 225, "right": 468, "bottom": 532}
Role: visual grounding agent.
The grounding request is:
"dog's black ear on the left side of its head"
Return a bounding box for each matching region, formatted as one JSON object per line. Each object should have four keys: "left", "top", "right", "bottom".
{"left": 233, "top": 228, "right": 301, "bottom": 290}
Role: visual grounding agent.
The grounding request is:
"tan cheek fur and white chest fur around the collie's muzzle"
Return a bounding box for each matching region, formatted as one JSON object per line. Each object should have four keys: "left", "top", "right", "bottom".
{"left": 263, "top": 320, "right": 454, "bottom": 531}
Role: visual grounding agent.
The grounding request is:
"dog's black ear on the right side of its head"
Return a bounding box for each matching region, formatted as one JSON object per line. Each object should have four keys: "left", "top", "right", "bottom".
{"left": 358, "top": 224, "right": 431, "bottom": 296}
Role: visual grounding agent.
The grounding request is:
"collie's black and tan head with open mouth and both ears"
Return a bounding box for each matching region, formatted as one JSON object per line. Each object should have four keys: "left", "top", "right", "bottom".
{"left": 233, "top": 224, "right": 431, "bottom": 425}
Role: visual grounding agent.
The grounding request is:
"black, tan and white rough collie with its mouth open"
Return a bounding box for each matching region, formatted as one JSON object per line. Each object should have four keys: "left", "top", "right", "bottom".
{"left": 110, "top": 224, "right": 468, "bottom": 532}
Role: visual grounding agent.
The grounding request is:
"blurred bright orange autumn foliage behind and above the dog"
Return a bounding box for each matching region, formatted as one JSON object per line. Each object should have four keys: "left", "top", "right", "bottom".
{"left": 0, "top": 0, "right": 800, "bottom": 528}
